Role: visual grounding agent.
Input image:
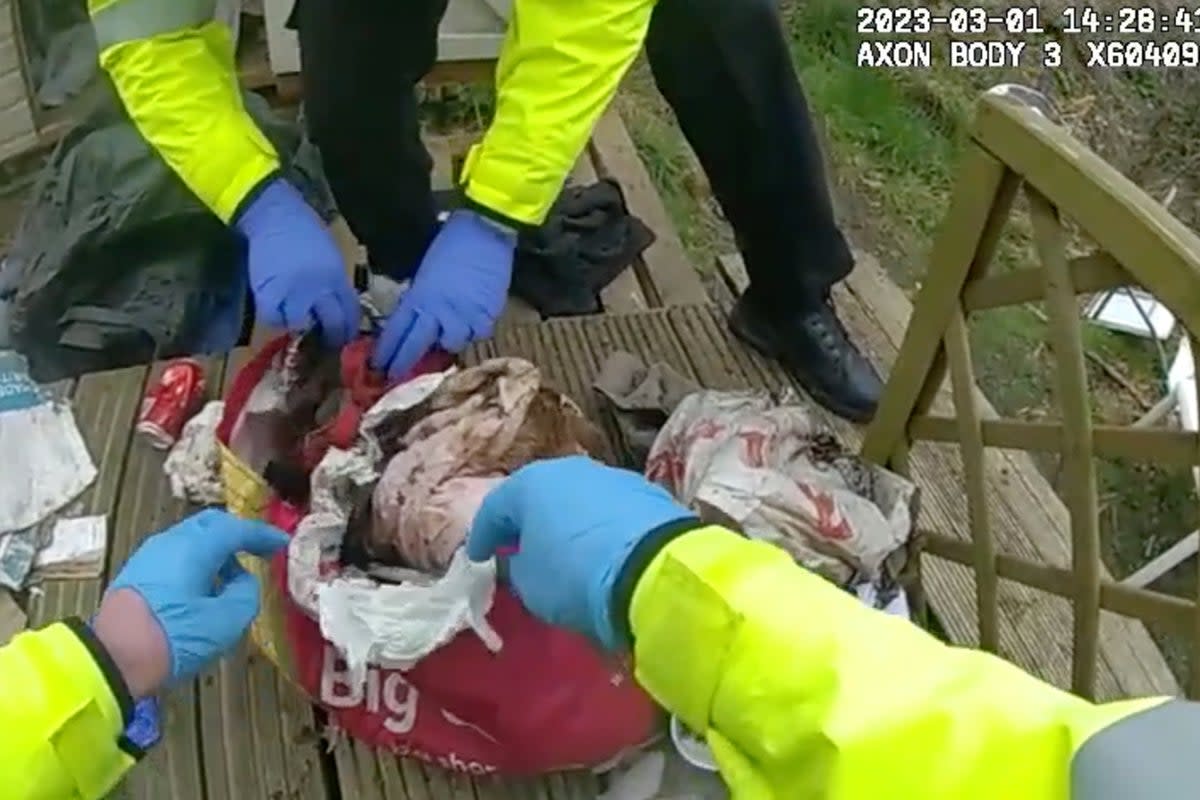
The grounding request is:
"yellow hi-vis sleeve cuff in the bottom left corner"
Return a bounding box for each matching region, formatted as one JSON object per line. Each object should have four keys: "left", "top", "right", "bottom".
{"left": 0, "top": 620, "right": 134, "bottom": 800}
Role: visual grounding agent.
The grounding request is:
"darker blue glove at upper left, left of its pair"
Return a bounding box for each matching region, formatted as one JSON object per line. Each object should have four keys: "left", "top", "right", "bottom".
{"left": 234, "top": 178, "right": 360, "bottom": 348}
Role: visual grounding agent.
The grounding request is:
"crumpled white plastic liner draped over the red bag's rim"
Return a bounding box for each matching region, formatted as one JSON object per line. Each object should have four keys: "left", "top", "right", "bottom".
{"left": 288, "top": 371, "right": 503, "bottom": 686}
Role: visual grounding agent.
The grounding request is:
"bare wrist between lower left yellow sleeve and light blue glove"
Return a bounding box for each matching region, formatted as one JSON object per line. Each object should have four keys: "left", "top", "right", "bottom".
{"left": 91, "top": 588, "right": 170, "bottom": 699}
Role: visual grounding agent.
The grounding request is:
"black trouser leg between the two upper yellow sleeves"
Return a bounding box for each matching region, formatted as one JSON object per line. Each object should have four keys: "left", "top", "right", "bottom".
{"left": 292, "top": 0, "right": 448, "bottom": 277}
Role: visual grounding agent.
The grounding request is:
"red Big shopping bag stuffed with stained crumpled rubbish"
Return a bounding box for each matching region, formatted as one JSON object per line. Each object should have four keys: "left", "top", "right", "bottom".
{"left": 204, "top": 338, "right": 658, "bottom": 774}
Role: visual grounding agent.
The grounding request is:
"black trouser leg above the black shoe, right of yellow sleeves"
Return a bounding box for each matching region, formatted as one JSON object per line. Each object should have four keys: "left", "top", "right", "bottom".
{"left": 646, "top": 0, "right": 853, "bottom": 312}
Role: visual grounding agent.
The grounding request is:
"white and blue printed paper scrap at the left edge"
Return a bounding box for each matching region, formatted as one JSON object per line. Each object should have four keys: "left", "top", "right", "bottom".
{"left": 0, "top": 350, "right": 96, "bottom": 534}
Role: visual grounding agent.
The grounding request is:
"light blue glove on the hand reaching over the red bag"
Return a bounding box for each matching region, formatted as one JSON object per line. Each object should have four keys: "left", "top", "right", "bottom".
{"left": 467, "top": 456, "right": 695, "bottom": 650}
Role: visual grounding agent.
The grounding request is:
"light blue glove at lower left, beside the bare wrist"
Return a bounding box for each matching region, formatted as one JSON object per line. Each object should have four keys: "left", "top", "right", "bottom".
{"left": 105, "top": 509, "right": 288, "bottom": 684}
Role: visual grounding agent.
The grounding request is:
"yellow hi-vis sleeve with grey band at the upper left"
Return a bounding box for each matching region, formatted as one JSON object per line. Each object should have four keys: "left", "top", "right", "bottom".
{"left": 88, "top": 0, "right": 280, "bottom": 222}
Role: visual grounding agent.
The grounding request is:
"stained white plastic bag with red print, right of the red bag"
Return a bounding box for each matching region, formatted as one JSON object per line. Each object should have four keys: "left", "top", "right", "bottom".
{"left": 646, "top": 391, "right": 917, "bottom": 592}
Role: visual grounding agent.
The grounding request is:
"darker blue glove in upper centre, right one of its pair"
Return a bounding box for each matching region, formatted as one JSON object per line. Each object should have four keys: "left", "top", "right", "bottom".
{"left": 371, "top": 210, "right": 517, "bottom": 378}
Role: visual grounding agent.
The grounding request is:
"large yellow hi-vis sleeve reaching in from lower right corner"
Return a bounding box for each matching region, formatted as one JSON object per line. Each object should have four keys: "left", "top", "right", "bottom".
{"left": 629, "top": 528, "right": 1176, "bottom": 800}
